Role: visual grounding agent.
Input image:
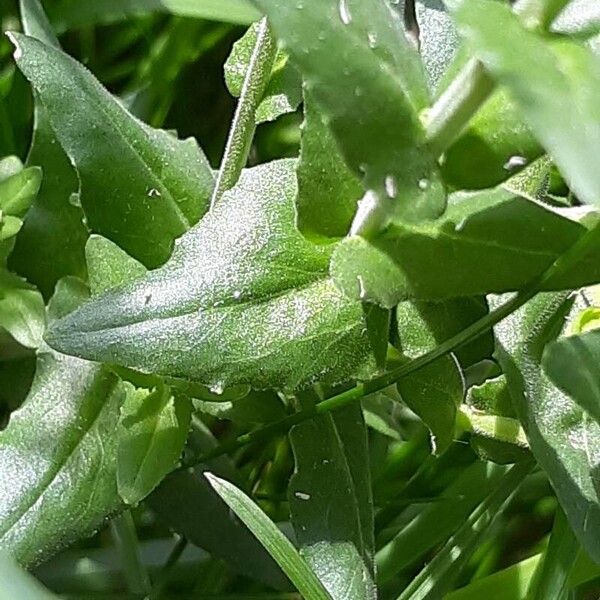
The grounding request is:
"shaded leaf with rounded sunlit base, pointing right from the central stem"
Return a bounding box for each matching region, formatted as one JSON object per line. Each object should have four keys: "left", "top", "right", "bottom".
{"left": 331, "top": 187, "right": 600, "bottom": 307}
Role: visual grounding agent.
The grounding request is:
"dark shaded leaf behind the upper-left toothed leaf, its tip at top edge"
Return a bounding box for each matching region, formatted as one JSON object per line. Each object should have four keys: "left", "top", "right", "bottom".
{"left": 9, "top": 0, "right": 87, "bottom": 298}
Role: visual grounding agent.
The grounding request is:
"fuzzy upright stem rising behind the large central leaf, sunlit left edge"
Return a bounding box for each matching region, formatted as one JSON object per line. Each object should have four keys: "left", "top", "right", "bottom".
{"left": 211, "top": 18, "right": 277, "bottom": 207}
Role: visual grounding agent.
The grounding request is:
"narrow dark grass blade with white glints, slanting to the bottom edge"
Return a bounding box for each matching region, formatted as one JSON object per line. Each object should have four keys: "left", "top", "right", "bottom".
{"left": 398, "top": 460, "right": 535, "bottom": 600}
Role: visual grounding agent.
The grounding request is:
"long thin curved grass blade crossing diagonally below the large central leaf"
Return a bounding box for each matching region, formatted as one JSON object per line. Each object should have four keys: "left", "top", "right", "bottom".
{"left": 180, "top": 222, "right": 600, "bottom": 468}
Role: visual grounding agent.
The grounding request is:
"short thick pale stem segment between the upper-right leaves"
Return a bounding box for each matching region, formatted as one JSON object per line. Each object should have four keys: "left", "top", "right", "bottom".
{"left": 426, "top": 58, "right": 495, "bottom": 156}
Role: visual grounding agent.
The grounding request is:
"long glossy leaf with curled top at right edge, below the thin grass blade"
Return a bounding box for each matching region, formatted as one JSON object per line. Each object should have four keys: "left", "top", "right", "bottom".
{"left": 496, "top": 294, "right": 600, "bottom": 561}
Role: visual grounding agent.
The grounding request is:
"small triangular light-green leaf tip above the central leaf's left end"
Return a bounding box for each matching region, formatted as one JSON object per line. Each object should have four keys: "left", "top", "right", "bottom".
{"left": 85, "top": 235, "right": 147, "bottom": 296}
